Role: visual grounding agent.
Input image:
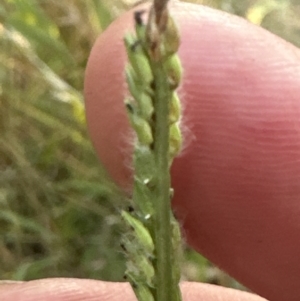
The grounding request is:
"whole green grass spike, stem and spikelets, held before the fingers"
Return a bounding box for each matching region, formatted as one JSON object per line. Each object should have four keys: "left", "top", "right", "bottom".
{"left": 122, "top": 1, "right": 182, "bottom": 301}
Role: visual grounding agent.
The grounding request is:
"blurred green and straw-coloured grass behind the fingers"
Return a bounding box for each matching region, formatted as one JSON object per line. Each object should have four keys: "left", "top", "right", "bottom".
{"left": 0, "top": 0, "right": 300, "bottom": 287}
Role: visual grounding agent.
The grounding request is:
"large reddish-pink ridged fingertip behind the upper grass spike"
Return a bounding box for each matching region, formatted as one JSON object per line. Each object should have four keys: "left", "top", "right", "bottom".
{"left": 85, "top": 3, "right": 300, "bottom": 301}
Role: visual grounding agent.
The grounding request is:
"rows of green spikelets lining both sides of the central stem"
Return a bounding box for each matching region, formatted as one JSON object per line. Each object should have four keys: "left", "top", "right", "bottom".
{"left": 122, "top": 4, "right": 182, "bottom": 301}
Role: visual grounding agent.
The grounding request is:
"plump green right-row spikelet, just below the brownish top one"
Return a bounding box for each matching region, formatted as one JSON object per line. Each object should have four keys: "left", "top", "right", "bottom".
{"left": 163, "top": 54, "right": 182, "bottom": 89}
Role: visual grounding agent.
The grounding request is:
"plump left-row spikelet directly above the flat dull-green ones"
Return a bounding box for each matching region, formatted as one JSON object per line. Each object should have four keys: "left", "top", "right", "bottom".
{"left": 125, "top": 100, "right": 153, "bottom": 145}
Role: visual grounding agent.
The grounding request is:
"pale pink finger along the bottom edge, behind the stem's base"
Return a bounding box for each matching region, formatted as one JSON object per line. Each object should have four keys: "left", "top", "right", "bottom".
{"left": 0, "top": 278, "right": 266, "bottom": 301}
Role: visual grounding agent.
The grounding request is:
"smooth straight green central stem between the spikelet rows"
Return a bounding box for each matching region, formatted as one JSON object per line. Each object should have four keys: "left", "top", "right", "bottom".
{"left": 152, "top": 63, "right": 175, "bottom": 301}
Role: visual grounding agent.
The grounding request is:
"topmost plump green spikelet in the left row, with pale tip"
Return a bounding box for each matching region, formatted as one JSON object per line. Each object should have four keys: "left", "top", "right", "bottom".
{"left": 124, "top": 34, "right": 153, "bottom": 86}
